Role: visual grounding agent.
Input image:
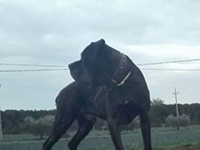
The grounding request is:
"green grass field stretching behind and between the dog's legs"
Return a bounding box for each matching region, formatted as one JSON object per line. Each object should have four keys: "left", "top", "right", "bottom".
{"left": 0, "top": 126, "right": 200, "bottom": 150}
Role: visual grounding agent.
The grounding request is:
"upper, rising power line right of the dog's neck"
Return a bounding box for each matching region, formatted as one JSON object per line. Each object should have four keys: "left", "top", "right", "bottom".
{"left": 137, "top": 59, "right": 200, "bottom": 66}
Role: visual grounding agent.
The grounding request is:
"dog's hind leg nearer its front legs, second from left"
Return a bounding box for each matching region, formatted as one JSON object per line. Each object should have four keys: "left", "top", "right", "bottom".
{"left": 68, "top": 116, "right": 96, "bottom": 150}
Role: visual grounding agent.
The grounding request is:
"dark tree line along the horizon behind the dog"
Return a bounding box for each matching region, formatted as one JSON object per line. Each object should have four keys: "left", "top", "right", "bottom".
{"left": 1, "top": 99, "right": 200, "bottom": 138}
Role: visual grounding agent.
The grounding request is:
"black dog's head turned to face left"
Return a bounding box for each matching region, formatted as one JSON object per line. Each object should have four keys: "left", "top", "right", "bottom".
{"left": 69, "top": 39, "right": 119, "bottom": 86}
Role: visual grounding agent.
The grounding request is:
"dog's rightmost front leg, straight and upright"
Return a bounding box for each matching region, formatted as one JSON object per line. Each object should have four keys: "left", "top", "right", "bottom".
{"left": 140, "top": 112, "right": 152, "bottom": 150}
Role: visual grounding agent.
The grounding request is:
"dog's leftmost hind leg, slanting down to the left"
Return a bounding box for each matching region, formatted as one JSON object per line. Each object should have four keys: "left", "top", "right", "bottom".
{"left": 42, "top": 115, "right": 75, "bottom": 150}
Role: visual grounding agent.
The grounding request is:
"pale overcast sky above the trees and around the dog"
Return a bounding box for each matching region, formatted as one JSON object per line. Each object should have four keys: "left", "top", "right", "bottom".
{"left": 0, "top": 0, "right": 200, "bottom": 110}
